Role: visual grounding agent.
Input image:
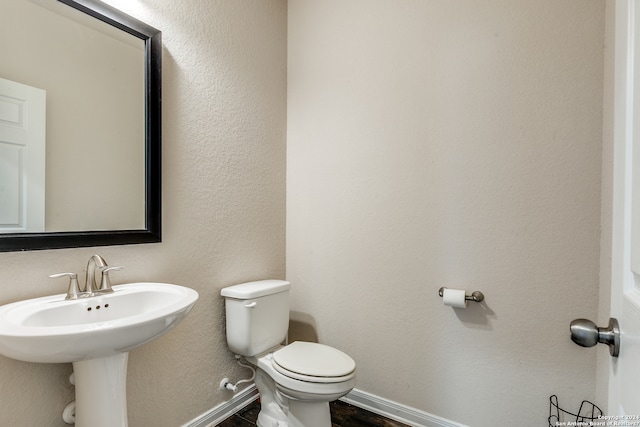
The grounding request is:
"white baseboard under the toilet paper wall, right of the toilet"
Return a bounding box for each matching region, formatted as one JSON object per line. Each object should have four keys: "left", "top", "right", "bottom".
{"left": 340, "top": 388, "right": 468, "bottom": 427}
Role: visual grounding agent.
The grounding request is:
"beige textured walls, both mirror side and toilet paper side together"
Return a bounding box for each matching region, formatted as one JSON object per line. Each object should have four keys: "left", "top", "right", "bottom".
{"left": 0, "top": 0, "right": 606, "bottom": 427}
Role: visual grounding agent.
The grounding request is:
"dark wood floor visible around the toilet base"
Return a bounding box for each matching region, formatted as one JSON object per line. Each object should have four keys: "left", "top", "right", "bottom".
{"left": 218, "top": 400, "right": 409, "bottom": 427}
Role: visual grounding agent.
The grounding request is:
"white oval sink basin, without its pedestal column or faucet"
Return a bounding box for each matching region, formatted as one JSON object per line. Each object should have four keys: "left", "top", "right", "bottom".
{"left": 0, "top": 283, "right": 198, "bottom": 363}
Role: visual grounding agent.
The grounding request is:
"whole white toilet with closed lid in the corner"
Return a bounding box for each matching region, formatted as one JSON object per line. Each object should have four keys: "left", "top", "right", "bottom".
{"left": 221, "top": 280, "right": 356, "bottom": 427}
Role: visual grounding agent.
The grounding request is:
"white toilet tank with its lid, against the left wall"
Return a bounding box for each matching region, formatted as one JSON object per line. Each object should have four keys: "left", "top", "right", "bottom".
{"left": 220, "top": 280, "right": 291, "bottom": 356}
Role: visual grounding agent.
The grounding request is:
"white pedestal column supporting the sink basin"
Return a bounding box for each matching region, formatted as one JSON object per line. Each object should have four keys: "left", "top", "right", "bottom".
{"left": 73, "top": 353, "right": 129, "bottom": 427}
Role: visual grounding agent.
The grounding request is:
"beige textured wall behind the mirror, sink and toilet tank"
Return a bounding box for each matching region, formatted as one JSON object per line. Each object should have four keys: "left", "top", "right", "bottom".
{"left": 0, "top": 0, "right": 287, "bottom": 427}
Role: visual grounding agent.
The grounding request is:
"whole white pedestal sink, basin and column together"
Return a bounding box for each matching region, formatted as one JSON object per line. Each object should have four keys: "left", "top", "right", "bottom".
{"left": 0, "top": 283, "right": 198, "bottom": 427}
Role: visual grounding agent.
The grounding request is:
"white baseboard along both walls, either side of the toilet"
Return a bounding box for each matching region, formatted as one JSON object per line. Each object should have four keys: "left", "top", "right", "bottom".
{"left": 182, "top": 384, "right": 468, "bottom": 427}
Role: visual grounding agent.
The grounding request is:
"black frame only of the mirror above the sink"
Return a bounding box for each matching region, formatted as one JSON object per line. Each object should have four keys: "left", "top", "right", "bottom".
{"left": 0, "top": 0, "right": 162, "bottom": 252}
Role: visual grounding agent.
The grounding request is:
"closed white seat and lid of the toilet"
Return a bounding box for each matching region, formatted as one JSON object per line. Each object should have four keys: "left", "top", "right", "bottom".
{"left": 271, "top": 341, "right": 356, "bottom": 383}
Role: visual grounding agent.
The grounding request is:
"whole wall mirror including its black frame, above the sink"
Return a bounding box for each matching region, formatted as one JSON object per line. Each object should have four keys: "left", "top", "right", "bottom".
{"left": 0, "top": 0, "right": 162, "bottom": 251}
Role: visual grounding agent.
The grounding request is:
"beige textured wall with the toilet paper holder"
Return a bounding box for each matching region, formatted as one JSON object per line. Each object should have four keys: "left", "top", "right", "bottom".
{"left": 287, "top": 0, "right": 606, "bottom": 427}
